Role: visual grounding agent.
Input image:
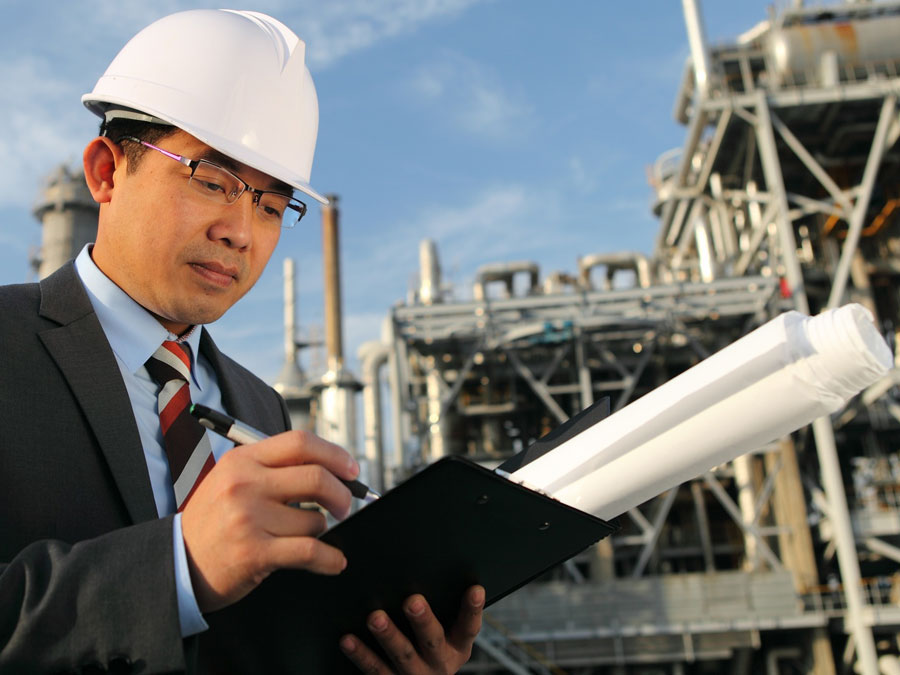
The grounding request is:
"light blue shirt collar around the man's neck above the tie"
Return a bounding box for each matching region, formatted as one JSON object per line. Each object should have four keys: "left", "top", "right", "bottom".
{"left": 75, "top": 244, "right": 200, "bottom": 387}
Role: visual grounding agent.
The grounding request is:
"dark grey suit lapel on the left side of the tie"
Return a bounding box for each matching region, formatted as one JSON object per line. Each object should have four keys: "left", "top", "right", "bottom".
{"left": 40, "top": 263, "right": 158, "bottom": 522}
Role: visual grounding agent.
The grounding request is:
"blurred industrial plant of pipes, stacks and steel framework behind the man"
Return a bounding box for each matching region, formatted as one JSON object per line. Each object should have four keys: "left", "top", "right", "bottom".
{"left": 35, "top": 0, "right": 900, "bottom": 675}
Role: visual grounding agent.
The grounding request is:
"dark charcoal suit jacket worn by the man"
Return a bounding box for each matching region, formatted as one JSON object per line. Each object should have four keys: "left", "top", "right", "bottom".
{"left": 0, "top": 263, "right": 289, "bottom": 673}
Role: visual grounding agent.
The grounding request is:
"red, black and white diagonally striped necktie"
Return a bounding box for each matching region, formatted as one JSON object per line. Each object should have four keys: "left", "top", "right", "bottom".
{"left": 144, "top": 340, "right": 215, "bottom": 511}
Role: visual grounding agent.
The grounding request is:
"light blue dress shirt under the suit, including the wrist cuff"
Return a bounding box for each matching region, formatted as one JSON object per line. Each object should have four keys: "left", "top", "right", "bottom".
{"left": 75, "top": 245, "right": 234, "bottom": 637}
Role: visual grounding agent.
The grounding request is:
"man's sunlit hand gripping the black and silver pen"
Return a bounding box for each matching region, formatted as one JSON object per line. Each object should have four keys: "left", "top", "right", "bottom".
{"left": 181, "top": 431, "right": 359, "bottom": 612}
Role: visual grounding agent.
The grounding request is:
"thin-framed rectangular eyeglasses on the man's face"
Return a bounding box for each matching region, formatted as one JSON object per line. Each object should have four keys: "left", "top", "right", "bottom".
{"left": 119, "top": 136, "right": 306, "bottom": 228}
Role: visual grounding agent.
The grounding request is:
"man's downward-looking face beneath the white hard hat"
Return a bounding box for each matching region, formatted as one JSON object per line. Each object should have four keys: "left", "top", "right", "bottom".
{"left": 92, "top": 131, "right": 281, "bottom": 334}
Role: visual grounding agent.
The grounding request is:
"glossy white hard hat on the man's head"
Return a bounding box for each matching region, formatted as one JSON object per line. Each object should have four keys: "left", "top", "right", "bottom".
{"left": 81, "top": 9, "right": 328, "bottom": 204}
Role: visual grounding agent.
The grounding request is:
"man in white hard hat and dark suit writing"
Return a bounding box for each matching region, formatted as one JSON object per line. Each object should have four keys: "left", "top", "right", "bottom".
{"left": 0, "top": 10, "right": 484, "bottom": 673}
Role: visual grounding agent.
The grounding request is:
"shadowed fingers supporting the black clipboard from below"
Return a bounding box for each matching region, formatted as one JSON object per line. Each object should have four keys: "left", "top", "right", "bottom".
{"left": 340, "top": 586, "right": 484, "bottom": 675}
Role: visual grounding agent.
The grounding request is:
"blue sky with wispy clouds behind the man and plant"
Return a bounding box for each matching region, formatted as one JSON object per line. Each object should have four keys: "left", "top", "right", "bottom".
{"left": 0, "top": 0, "right": 780, "bottom": 381}
